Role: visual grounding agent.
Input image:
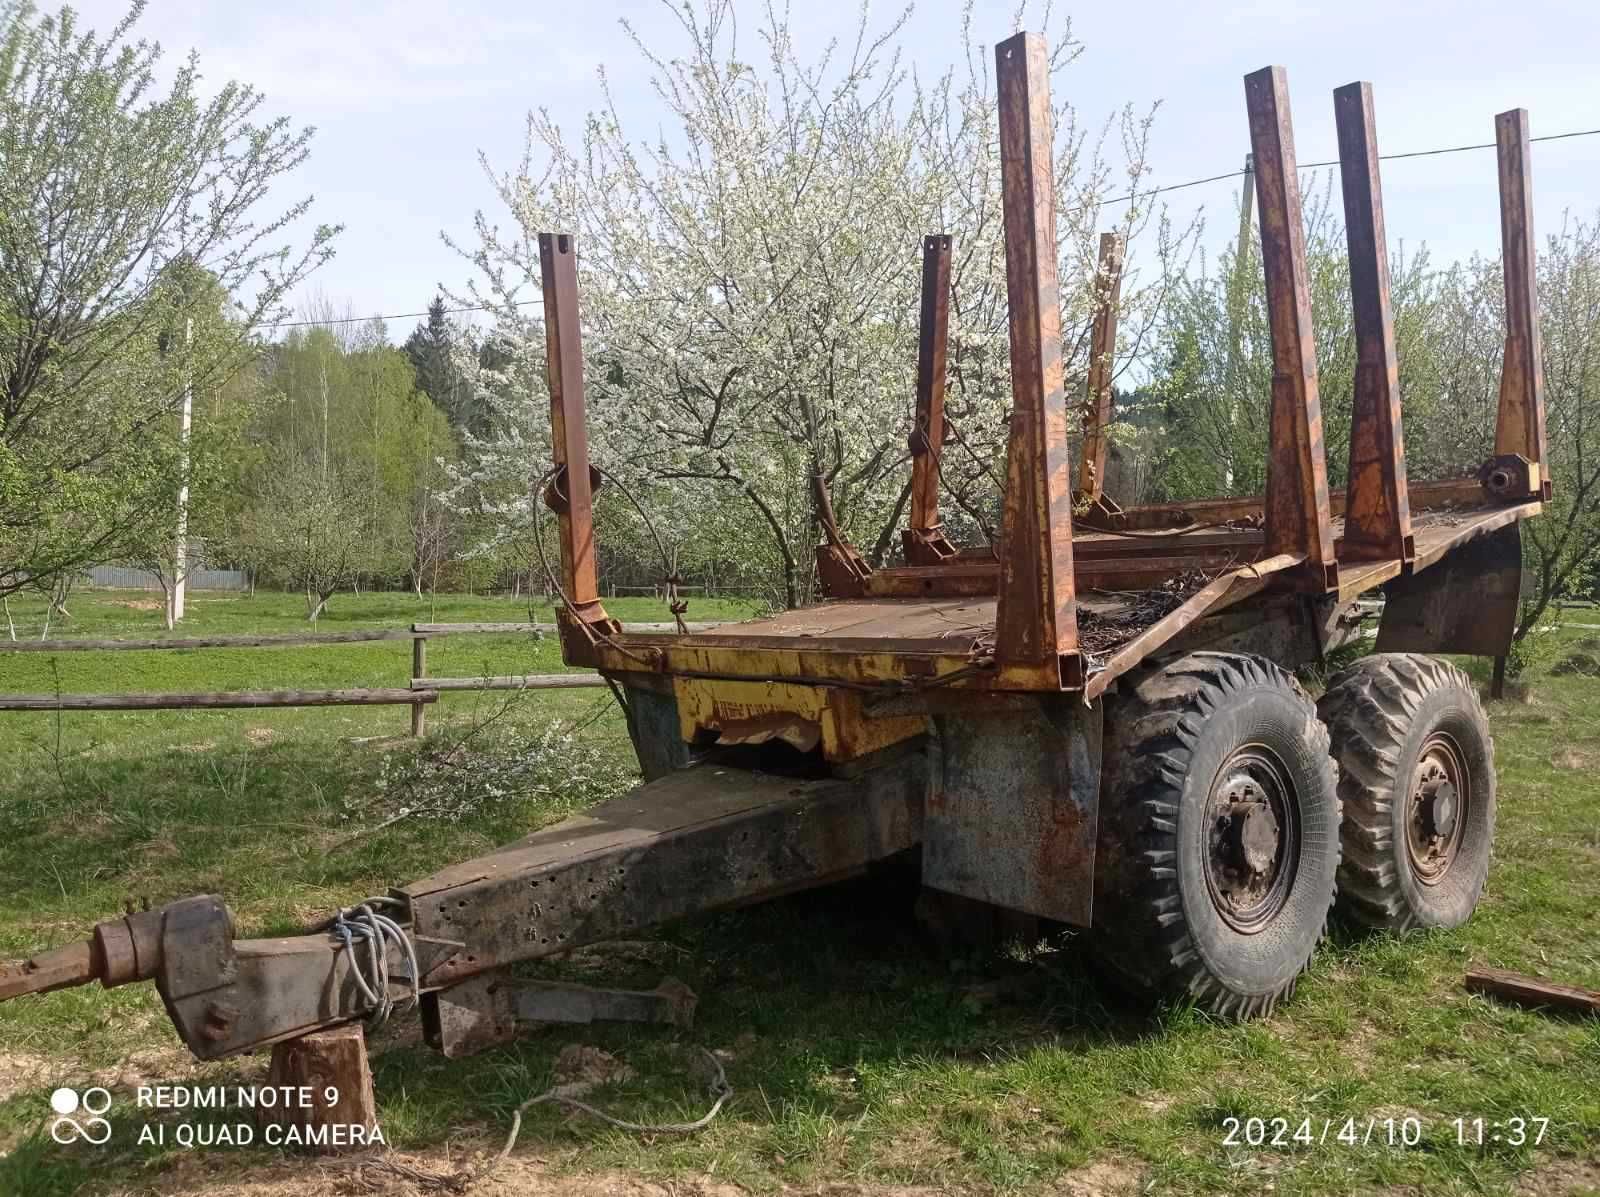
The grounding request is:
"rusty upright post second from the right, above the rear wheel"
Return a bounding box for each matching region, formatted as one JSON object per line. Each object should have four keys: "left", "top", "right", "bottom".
{"left": 1333, "top": 83, "right": 1416, "bottom": 560}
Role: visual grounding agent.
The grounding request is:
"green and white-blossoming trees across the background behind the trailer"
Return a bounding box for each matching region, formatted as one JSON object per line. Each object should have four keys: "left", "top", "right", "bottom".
{"left": 0, "top": 0, "right": 1600, "bottom": 649}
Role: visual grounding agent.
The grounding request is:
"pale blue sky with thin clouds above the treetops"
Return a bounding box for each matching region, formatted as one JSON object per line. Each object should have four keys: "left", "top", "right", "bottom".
{"left": 75, "top": 0, "right": 1600, "bottom": 341}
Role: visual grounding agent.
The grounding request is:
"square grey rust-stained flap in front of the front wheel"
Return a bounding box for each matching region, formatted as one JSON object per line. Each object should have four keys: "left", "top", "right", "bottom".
{"left": 922, "top": 695, "right": 1101, "bottom": 927}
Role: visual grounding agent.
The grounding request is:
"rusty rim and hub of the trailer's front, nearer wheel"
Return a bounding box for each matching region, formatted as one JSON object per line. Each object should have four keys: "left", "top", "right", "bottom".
{"left": 1203, "top": 744, "right": 1299, "bottom": 935}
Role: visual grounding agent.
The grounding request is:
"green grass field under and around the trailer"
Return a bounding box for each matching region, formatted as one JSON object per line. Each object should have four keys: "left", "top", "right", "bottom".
{"left": 0, "top": 594, "right": 1600, "bottom": 1197}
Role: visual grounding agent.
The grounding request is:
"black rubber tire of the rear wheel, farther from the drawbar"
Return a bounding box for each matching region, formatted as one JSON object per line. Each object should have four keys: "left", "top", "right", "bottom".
{"left": 1317, "top": 653, "right": 1494, "bottom": 931}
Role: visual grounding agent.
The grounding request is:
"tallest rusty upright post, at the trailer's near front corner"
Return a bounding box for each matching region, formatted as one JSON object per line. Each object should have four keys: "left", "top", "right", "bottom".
{"left": 995, "top": 34, "right": 1082, "bottom": 687}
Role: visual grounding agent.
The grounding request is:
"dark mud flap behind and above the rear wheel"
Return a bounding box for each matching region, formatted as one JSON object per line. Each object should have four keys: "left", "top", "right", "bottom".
{"left": 1378, "top": 523, "right": 1522, "bottom": 656}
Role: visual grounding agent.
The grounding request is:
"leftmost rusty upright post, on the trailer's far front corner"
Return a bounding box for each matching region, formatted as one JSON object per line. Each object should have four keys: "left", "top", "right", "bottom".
{"left": 539, "top": 232, "right": 619, "bottom": 661}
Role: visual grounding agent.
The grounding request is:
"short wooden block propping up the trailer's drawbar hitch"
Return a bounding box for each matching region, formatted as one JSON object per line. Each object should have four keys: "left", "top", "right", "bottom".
{"left": 258, "top": 1023, "right": 382, "bottom": 1152}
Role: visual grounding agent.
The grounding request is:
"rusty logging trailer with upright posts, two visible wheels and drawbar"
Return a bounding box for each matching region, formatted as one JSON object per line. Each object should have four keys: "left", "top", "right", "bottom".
{"left": 0, "top": 34, "right": 1550, "bottom": 1059}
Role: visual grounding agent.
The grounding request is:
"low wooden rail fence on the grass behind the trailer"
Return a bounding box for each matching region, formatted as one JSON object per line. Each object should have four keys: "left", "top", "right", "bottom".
{"left": 0, "top": 623, "right": 714, "bottom": 736}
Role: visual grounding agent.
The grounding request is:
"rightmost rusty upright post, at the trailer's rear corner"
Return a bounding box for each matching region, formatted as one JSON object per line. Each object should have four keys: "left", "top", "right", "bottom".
{"left": 1494, "top": 109, "right": 1550, "bottom": 499}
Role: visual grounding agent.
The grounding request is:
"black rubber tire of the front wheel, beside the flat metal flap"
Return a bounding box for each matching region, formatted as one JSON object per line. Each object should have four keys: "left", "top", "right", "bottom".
{"left": 1090, "top": 653, "right": 1339, "bottom": 1018}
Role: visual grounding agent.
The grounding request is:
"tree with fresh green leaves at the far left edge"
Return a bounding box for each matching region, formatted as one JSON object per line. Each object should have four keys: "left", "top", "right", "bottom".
{"left": 0, "top": 2, "right": 334, "bottom": 595}
